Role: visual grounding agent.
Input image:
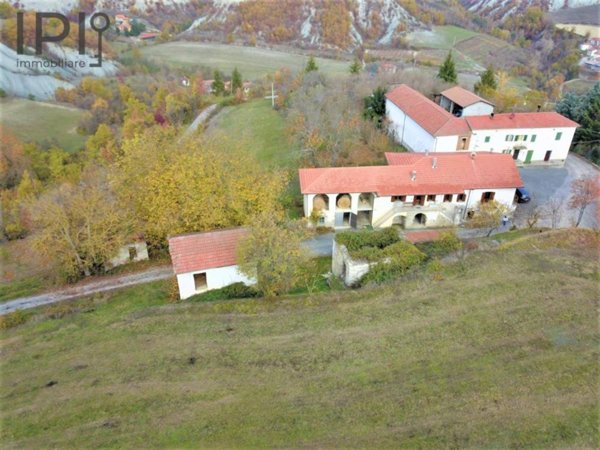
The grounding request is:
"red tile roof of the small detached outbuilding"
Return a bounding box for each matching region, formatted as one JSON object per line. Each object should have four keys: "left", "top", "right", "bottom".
{"left": 169, "top": 228, "right": 248, "bottom": 274}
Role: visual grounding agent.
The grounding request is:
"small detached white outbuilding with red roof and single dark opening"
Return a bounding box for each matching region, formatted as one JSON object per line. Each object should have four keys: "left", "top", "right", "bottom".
{"left": 169, "top": 228, "right": 254, "bottom": 300}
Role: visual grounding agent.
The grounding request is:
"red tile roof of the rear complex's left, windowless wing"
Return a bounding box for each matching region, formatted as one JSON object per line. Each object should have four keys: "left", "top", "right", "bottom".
{"left": 386, "top": 84, "right": 470, "bottom": 136}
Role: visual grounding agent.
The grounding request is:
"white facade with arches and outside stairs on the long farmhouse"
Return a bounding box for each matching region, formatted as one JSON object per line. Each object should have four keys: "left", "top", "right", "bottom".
{"left": 303, "top": 188, "right": 516, "bottom": 229}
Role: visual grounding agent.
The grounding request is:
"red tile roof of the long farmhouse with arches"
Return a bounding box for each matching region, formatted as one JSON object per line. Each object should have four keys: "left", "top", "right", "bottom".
{"left": 299, "top": 152, "right": 523, "bottom": 196}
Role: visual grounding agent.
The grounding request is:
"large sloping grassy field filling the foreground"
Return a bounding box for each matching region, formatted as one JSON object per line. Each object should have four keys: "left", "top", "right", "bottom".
{"left": 0, "top": 231, "right": 600, "bottom": 448}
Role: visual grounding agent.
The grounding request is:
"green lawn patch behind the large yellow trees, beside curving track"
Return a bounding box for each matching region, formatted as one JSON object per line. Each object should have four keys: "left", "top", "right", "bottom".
{"left": 209, "top": 99, "right": 298, "bottom": 167}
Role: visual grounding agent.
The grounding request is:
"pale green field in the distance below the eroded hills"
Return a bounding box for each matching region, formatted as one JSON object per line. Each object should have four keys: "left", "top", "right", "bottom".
{"left": 141, "top": 42, "right": 350, "bottom": 80}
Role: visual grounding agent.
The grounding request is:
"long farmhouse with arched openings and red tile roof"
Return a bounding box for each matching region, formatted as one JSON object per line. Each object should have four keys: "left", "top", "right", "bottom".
{"left": 299, "top": 152, "right": 523, "bottom": 229}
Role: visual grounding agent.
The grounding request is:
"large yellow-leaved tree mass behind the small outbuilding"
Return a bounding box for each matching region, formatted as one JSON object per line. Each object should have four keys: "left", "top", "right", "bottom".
{"left": 114, "top": 126, "right": 286, "bottom": 246}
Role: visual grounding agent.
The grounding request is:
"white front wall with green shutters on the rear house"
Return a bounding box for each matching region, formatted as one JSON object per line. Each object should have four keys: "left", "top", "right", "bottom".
{"left": 469, "top": 128, "right": 575, "bottom": 163}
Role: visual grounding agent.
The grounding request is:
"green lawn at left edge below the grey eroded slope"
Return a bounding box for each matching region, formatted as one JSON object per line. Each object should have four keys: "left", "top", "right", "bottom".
{"left": 0, "top": 98, "right": 86, "bottom": 152}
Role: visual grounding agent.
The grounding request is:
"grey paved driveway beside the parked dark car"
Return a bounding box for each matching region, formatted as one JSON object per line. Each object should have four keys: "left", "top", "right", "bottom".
{"left": 514, "top": 154, "right": 600, "bottom": 228}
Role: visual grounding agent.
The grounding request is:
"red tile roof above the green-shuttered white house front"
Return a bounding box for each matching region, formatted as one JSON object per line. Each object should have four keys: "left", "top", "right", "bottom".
{"left": 465, "top": 111, "right": 579, "bottom": 130}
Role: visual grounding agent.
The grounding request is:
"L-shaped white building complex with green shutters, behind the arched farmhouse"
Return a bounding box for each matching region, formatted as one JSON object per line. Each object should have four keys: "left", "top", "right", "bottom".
{"left": 386, "top": 85, "right": 578, "bottom": 164}
